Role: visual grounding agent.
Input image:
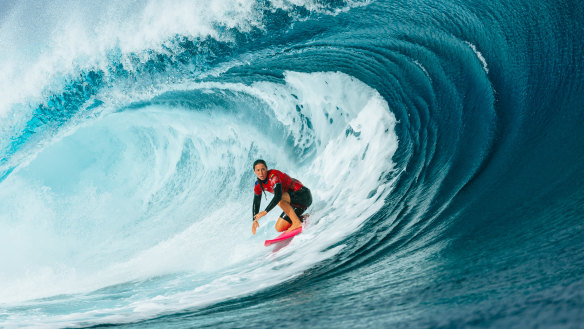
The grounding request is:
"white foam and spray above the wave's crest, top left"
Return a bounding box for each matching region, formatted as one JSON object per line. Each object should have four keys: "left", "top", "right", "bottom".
{"left": 0, "top": 0, "right": 367, "bottom": 120}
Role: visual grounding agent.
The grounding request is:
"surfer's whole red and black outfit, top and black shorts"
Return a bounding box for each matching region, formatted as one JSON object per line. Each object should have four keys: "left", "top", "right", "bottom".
{"left": 252, "top": 169, "right": 312, "bottom": 224}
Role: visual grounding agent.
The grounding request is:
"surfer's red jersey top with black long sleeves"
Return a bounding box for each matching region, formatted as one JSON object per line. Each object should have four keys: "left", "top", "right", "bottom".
{"left": 252, "top": 169, "right": 304, "bottom": 216}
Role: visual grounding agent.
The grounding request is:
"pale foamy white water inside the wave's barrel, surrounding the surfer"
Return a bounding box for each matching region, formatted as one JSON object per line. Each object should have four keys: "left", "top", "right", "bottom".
{"left": 1, "top": 68, "right": 397, "bottom": 321}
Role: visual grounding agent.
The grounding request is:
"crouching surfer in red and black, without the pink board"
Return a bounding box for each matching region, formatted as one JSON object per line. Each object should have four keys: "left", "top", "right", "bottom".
{"left": 251, "top": 159, "right": 312, "bottom": 234}
